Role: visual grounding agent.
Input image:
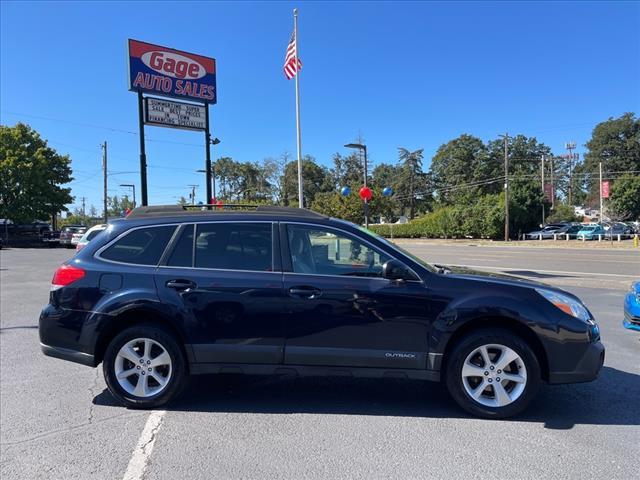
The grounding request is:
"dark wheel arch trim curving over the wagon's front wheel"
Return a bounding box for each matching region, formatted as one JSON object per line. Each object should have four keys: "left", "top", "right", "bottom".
{"left": 442, "top": 317, "right": 549, "bottom": 381}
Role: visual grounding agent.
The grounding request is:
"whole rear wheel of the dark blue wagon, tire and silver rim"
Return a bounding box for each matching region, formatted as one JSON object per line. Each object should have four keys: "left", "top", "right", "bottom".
{"left": 102, "top": 325, "right": 187, "bottom": 408}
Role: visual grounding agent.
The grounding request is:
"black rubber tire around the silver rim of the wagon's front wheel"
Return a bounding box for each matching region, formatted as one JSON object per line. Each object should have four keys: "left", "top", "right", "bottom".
{"left": 445, "top": 328, "right": 540, "bottom": 418}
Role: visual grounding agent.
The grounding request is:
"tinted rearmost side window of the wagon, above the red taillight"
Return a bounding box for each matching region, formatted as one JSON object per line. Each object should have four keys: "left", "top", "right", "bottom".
{"left": 101, "top": 226, "right": 176, "bottom": 265}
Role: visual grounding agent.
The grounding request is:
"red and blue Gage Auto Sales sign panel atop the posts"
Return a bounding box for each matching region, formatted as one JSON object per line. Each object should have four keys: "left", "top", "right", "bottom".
{"left": 129, "top": 39, "right": 217, "bottom": 103}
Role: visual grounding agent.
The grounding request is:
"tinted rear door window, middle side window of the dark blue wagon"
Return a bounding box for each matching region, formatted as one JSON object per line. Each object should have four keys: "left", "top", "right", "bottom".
{"left": 195, "top": 223, "right": 273, "bottom": 272}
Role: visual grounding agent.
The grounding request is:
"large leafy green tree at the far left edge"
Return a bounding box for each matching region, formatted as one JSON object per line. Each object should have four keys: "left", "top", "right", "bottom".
{"left": 0, "top": 123, "right": 73, "bottom": 223}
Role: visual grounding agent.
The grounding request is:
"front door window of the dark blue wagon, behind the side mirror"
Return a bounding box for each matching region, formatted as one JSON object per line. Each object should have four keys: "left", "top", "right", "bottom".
{"left": 287, "top": 225, "right": 391, "bottom": 277}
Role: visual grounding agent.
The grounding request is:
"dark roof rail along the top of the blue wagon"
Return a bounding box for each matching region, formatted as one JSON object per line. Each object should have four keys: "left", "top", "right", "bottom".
{"left": 126, "top": 203, "right": 326, "bottom": 219}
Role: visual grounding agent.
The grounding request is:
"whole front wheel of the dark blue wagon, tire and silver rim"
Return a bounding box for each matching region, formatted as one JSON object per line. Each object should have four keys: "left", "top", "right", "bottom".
{"left": 446, "top": 329, "right": 540, "bottom": 418}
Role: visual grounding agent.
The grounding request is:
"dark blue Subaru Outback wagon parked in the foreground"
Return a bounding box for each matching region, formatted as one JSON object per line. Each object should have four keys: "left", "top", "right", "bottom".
{"left": 39, "top": 205, "right": 605, "bottom": 418}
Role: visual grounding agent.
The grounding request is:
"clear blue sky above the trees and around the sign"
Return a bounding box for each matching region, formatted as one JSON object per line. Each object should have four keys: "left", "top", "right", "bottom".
{"left": 0, "top": 1, "right": 640, "bottom": 210}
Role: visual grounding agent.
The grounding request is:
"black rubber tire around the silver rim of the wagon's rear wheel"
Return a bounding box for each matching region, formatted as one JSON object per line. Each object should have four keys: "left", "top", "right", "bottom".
{"left": 102, "top": 325, "right": 188, "bottom": 409}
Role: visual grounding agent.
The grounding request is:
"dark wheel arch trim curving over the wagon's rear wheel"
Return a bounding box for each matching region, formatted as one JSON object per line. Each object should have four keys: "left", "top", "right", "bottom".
{"left": 94, "top": 307, "right": 193, "bottom": 365}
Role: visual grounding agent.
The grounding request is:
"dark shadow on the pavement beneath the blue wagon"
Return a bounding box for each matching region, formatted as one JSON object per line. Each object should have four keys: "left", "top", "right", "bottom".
{"left": 93, "top": 367, "right": 640, "bottom": 430}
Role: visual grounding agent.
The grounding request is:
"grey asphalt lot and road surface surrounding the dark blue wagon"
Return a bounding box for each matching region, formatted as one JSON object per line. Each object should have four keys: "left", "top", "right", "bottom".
{"left": 0, "top": 246, "right": 640, "bottom": 479}
